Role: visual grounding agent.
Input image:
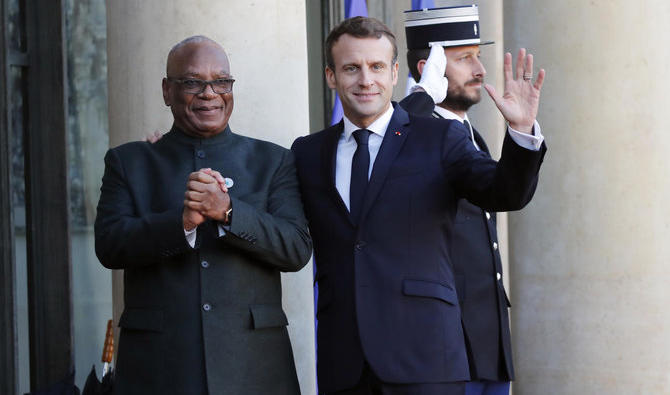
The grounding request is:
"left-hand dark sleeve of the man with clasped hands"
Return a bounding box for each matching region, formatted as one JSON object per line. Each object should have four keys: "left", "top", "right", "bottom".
{"left": 95, "top": 149, "right": 191, "bottom": 269}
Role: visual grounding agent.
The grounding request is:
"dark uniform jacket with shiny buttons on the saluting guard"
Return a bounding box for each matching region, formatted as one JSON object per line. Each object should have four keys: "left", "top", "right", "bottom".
{"left": 400, "top": 93, "right": 536, "bottom": 381}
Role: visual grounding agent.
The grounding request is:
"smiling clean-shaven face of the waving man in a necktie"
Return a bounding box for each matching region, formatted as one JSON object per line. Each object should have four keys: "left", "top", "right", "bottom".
{"left": 326, "top": 34, "right": 398, "bottom": 128}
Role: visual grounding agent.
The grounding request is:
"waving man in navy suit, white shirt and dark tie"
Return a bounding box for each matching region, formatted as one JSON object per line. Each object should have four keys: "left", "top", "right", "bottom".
{"left": 292, "top": 17, "right": 544, "bottom": 395}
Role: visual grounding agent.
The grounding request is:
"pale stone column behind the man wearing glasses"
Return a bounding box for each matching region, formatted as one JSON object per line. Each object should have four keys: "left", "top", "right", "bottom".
{"left": 107, "top": 0, "right": 316, "bottom": 394}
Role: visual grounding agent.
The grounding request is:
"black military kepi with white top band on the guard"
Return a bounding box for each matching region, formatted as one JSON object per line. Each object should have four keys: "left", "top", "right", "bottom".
{"left": 405, "top": 5, "right": 493, "bottom": 50}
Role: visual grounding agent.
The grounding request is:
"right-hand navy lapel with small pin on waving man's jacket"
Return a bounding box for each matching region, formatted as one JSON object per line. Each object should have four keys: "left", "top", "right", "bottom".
{"left": 359, "top": 103, "right": 410, "bottom": 223}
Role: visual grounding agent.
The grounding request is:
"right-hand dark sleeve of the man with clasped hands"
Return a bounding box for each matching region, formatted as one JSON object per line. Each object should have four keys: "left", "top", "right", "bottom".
{"left": 221, "top": 150, "right": 312, "bottom": 271}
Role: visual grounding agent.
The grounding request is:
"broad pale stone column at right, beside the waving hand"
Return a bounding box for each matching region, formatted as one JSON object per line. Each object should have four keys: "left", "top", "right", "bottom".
{"left": 504, "top": 0, "right": 670, "bottom": 394}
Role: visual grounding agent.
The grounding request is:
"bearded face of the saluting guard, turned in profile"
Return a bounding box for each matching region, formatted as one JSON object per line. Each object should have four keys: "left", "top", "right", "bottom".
{"left": 440, "top": 45, "right": 486, "bottom": 113}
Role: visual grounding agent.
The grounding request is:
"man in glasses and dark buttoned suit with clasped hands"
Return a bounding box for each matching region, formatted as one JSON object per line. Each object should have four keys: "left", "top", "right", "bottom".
{"left": 95, "top": 36, "right": 311, "bottom": 395}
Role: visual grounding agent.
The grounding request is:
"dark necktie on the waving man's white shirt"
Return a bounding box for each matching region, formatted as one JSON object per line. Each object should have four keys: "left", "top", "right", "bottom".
{"left": 349, "top": 129, "right": 370, "bottom": 223}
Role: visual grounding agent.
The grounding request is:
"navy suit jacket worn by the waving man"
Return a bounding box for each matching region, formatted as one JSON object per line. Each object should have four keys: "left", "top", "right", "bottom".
{"left": 292, "top": 104, "right": 544, "bottom": 393}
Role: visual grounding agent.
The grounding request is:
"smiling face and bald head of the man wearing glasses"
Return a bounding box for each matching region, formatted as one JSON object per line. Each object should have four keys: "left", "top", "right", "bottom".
{"left": 163, "top": 41, "right": 233, "bottom": 138}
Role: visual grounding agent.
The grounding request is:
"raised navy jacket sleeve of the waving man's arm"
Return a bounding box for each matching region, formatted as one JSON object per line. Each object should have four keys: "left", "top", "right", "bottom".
{"left": 442, "top": 122, "right": 547, "bottom": 211}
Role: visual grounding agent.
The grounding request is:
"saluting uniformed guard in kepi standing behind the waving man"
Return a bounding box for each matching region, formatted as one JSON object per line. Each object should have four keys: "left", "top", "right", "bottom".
{"left": 400, "top": 7, "right": 539, "bottom": 395}
